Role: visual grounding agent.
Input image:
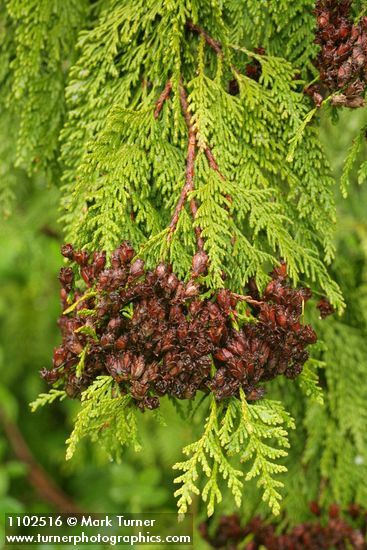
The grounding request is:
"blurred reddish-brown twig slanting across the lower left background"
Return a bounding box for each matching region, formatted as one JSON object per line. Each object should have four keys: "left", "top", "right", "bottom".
{"left": 0, "top": 409, "right": 83, "bottom": 514}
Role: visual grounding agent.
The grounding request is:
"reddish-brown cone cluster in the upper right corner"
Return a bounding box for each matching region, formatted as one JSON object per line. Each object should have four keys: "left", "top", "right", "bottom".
{"left": 305, "top": 0, "right": 367, "bottom": 108}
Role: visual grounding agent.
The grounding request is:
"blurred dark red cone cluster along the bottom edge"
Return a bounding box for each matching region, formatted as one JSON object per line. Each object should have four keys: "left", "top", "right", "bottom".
{"left": 199, "top": 502, "right": 367, "bottom": 550}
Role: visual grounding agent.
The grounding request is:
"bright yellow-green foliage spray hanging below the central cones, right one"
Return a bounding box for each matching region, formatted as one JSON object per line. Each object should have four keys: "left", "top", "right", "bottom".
{"left": 174, "top": 392, "right": 295, "bottom": 516}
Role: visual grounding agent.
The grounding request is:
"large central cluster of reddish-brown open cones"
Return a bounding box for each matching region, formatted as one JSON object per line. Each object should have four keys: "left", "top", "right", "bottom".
{"left": 41, "top": 242, "right": 317, "bottom": 410}
